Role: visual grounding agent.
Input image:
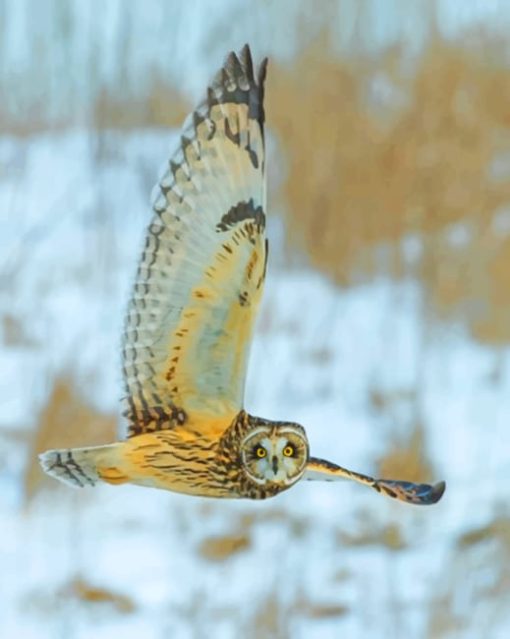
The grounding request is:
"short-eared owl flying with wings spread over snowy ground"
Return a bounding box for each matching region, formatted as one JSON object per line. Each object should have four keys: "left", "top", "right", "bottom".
{"left": 40, "top": 46, "right": 445, "bottom": 504}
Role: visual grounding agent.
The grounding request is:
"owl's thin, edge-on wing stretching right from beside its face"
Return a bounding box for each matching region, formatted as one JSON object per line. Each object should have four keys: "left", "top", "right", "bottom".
{"left": 304, "top": 457, "right": 446, "bottom": 506}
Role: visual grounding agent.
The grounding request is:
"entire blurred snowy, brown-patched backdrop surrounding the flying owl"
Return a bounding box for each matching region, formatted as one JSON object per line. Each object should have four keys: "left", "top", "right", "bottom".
{"left": 0, "top": 0, "right": 510, "bottom": 639}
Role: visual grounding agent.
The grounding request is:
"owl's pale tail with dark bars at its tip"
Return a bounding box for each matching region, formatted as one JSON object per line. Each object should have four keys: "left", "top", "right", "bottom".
{"left": 39, "top": 443, "right": 129, "bottom": 488}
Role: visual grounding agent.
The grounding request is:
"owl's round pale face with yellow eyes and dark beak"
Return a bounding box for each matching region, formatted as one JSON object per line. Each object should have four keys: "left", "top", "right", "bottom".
{"left": 241, "top": 422, "right": 308, "bottom": 490}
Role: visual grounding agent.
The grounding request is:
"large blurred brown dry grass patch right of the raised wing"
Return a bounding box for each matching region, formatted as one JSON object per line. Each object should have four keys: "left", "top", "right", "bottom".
{"left": 268, "top": 34, "right": 510, "bottom": 343}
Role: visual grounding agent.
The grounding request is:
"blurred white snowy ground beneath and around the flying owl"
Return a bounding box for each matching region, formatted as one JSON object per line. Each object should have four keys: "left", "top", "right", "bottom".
{"left": 0, "top": 132, "right": 510, "bottom": 639}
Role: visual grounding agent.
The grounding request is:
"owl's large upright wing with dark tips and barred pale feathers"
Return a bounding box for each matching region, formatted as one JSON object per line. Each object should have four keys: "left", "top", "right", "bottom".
{"left": 123, "top": 46, "right": 267, "bottom": 435}
